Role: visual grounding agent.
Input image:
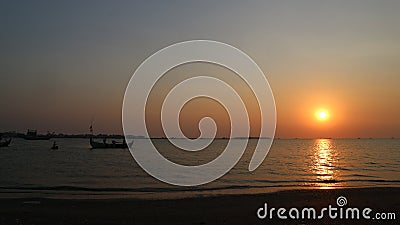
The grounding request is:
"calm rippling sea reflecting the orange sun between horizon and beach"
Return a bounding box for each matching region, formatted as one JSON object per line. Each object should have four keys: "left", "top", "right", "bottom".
{"left": 0, "top": 139, "right": 400, "bottom": 198}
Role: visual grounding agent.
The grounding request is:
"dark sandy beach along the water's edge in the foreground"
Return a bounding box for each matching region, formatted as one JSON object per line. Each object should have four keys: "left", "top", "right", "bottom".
{"left": 0, "top": 188, "right": 400, "bottom": 225}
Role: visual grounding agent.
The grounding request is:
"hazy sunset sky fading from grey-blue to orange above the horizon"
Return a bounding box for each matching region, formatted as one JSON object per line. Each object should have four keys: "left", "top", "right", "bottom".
{"left": 0, "top": 0, "right": 400, "bottom": 138}
